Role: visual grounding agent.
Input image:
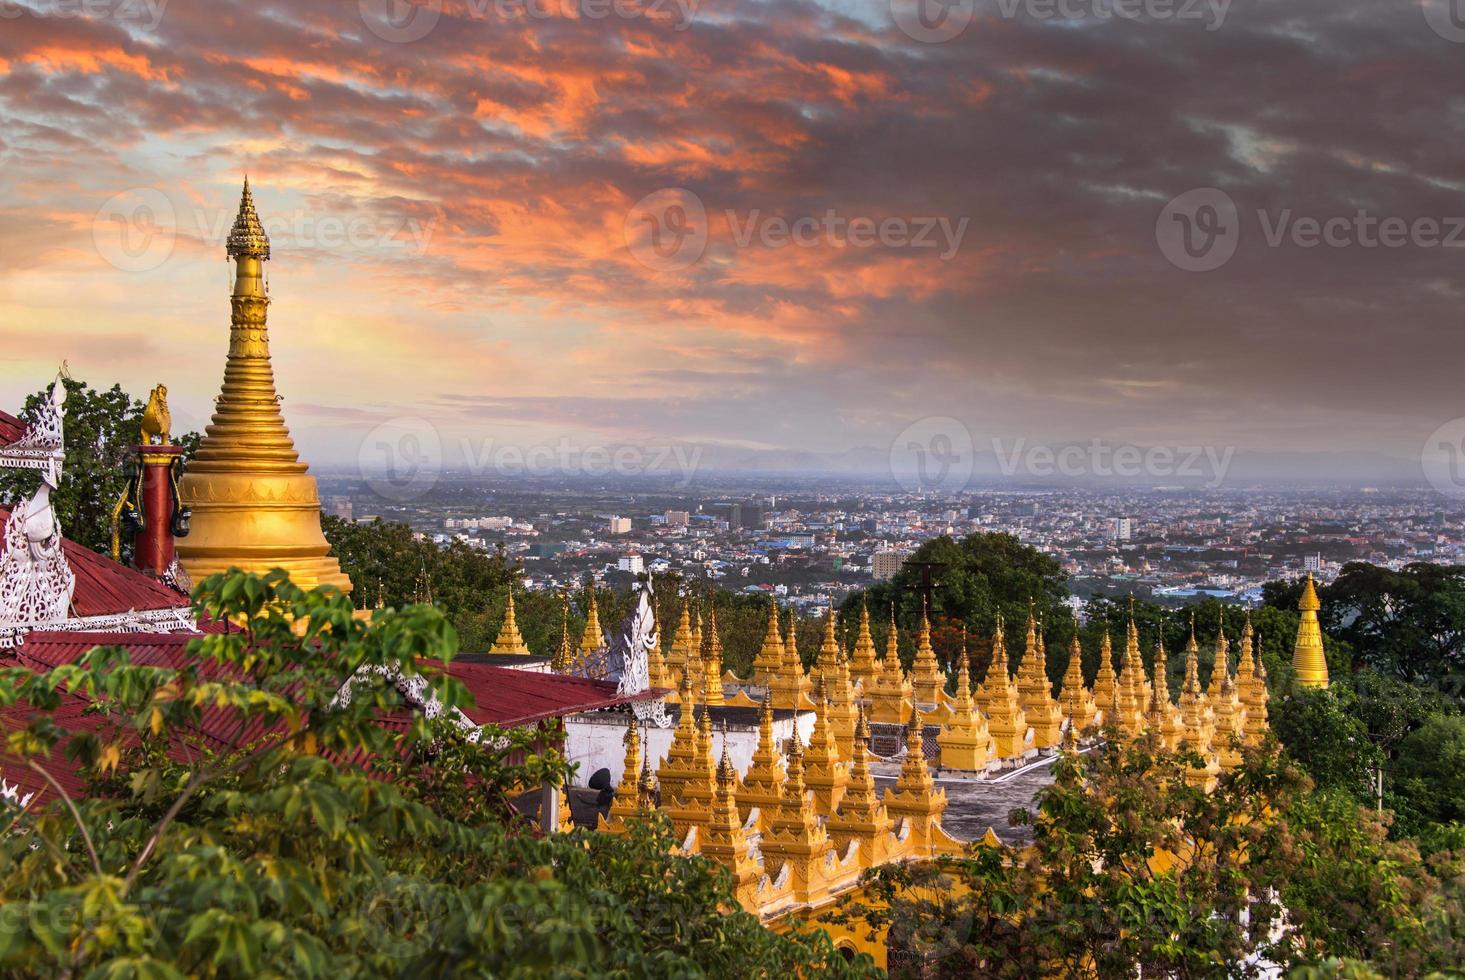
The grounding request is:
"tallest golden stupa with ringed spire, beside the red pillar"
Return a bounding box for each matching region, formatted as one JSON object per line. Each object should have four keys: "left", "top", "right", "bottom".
{"left": 176, "top": 179, "right": 352, "bottom": 592}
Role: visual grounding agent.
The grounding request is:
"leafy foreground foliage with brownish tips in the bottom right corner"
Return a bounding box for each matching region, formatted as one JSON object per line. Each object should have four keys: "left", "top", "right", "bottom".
{"left": 858, "top": 738, "right": 1465, "bottom": 977}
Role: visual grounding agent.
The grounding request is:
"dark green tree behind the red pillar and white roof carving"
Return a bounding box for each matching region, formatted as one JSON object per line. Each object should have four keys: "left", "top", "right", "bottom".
{"left": 0, "top": 378, "right": 199, "bottom": 555}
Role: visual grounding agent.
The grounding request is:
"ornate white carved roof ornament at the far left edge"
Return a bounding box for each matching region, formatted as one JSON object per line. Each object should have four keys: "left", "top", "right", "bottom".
{"left": 0, "top": 378, "right": 76, "bottom": 626}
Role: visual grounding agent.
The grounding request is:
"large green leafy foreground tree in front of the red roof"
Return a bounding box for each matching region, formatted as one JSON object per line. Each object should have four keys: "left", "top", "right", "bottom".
{"left": 0, "top": 573, "right": 872, "bottom": 977}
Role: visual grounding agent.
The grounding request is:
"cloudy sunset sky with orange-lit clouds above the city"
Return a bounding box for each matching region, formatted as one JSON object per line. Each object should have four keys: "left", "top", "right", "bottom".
{"left": 0, "top": 0, "right": 1465, "bottom": 480}
